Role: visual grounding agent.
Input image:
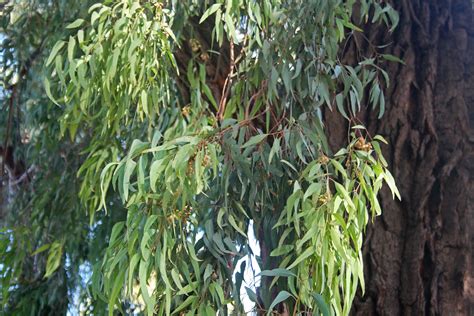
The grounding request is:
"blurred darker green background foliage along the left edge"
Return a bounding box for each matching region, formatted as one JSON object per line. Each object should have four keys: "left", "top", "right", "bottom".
{"left": 0, "top": 0, "right": 124, "bottom": 315}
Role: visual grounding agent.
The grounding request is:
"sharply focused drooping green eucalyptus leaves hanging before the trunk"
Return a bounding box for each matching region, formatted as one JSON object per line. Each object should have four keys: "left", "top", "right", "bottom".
{"left": 1, "top": 0, "right": 399, "bottom": 315}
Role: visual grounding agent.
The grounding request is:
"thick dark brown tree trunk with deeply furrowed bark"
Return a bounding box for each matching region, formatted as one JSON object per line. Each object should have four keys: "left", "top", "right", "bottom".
{"left": 327, "top": 0, "right": 474, "bottom": 315}
